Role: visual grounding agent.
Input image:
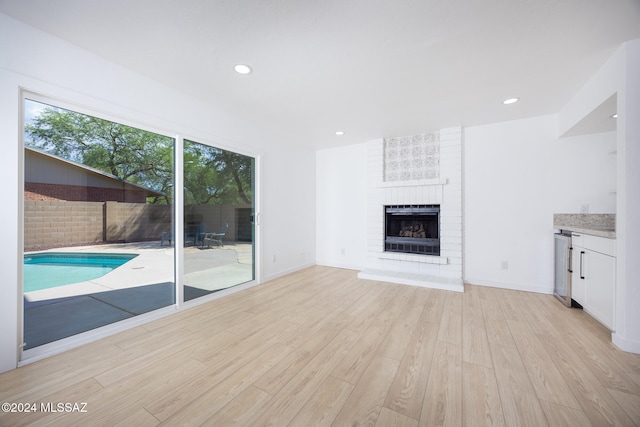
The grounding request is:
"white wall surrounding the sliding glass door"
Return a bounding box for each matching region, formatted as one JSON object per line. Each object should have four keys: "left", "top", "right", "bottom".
{"left": 0, "top": 14, "right": 315, "bottom": 372}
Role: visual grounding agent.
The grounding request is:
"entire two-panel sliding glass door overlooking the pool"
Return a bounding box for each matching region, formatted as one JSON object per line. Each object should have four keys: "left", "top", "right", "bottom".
{"left": 21, "top": 95, "right": 256, "bottom": 357}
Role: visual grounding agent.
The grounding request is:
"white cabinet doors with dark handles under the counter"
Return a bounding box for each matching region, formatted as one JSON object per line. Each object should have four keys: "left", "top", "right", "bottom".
{"left": 571, "top": 234, "right": 616, "bottom": 331}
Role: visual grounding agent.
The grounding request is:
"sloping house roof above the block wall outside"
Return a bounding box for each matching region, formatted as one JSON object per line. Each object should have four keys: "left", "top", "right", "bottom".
{"left": 24, "top": 145, "right": 166, "bottom": 197}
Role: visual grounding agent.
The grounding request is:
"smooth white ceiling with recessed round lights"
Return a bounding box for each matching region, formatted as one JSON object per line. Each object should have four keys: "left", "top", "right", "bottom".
{"left": 0, "top": 0, "right": 640, "bottom": 148}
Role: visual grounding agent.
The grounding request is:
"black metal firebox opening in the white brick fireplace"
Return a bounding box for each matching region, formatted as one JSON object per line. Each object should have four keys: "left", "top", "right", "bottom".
{"left": 384, "top": 205, "right": 440, "bottom": 256}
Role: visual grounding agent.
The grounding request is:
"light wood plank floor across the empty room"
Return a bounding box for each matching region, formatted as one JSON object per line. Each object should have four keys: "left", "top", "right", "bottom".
{"left": 0, "top": 267, "right": 640, "bottom": 427}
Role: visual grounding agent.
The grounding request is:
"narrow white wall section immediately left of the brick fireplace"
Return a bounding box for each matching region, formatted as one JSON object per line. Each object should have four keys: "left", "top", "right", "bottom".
{"left": 316, "top": 143, "right": 367, "bottom": 270}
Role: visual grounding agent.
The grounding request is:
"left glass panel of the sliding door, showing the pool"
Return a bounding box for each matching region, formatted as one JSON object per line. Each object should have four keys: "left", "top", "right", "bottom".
{"left": 23, "top": 99, "right": 175, "bottom": 350}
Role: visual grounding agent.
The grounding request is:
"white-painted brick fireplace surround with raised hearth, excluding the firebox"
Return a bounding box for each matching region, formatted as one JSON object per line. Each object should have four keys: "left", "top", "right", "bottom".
{"left": 358, "top": 127, "right": 464, "bottom": 292}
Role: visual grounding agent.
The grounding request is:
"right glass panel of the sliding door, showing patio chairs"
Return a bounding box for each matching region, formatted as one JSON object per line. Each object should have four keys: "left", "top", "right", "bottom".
{"left": 184, "top": 140, "right": 255, "bottom": 301}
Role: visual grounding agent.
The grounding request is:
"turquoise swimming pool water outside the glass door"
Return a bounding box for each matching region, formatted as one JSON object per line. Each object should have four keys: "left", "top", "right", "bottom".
{"left": 24, "top": 252, "right": 138, "bottom": 292}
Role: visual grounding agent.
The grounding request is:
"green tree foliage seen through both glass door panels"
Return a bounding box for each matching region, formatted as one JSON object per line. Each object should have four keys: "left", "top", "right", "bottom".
{"left": 25, "top": 101, "right": 253, "bottom": 205}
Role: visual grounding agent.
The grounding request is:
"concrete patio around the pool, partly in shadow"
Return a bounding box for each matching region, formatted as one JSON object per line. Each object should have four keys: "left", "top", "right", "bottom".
{"left": 24, "top": 242, "right": 253, "bottom": 349}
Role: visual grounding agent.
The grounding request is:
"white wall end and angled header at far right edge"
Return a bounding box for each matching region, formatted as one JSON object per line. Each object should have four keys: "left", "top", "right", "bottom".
{"left": 559, "top": 39, "right": 640, "bottom": 353}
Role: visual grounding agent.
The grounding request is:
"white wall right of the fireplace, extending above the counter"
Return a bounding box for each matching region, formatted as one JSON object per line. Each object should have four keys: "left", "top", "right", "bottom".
{"left": 463, "top": 116, "right": 616, "bottom": 293}
